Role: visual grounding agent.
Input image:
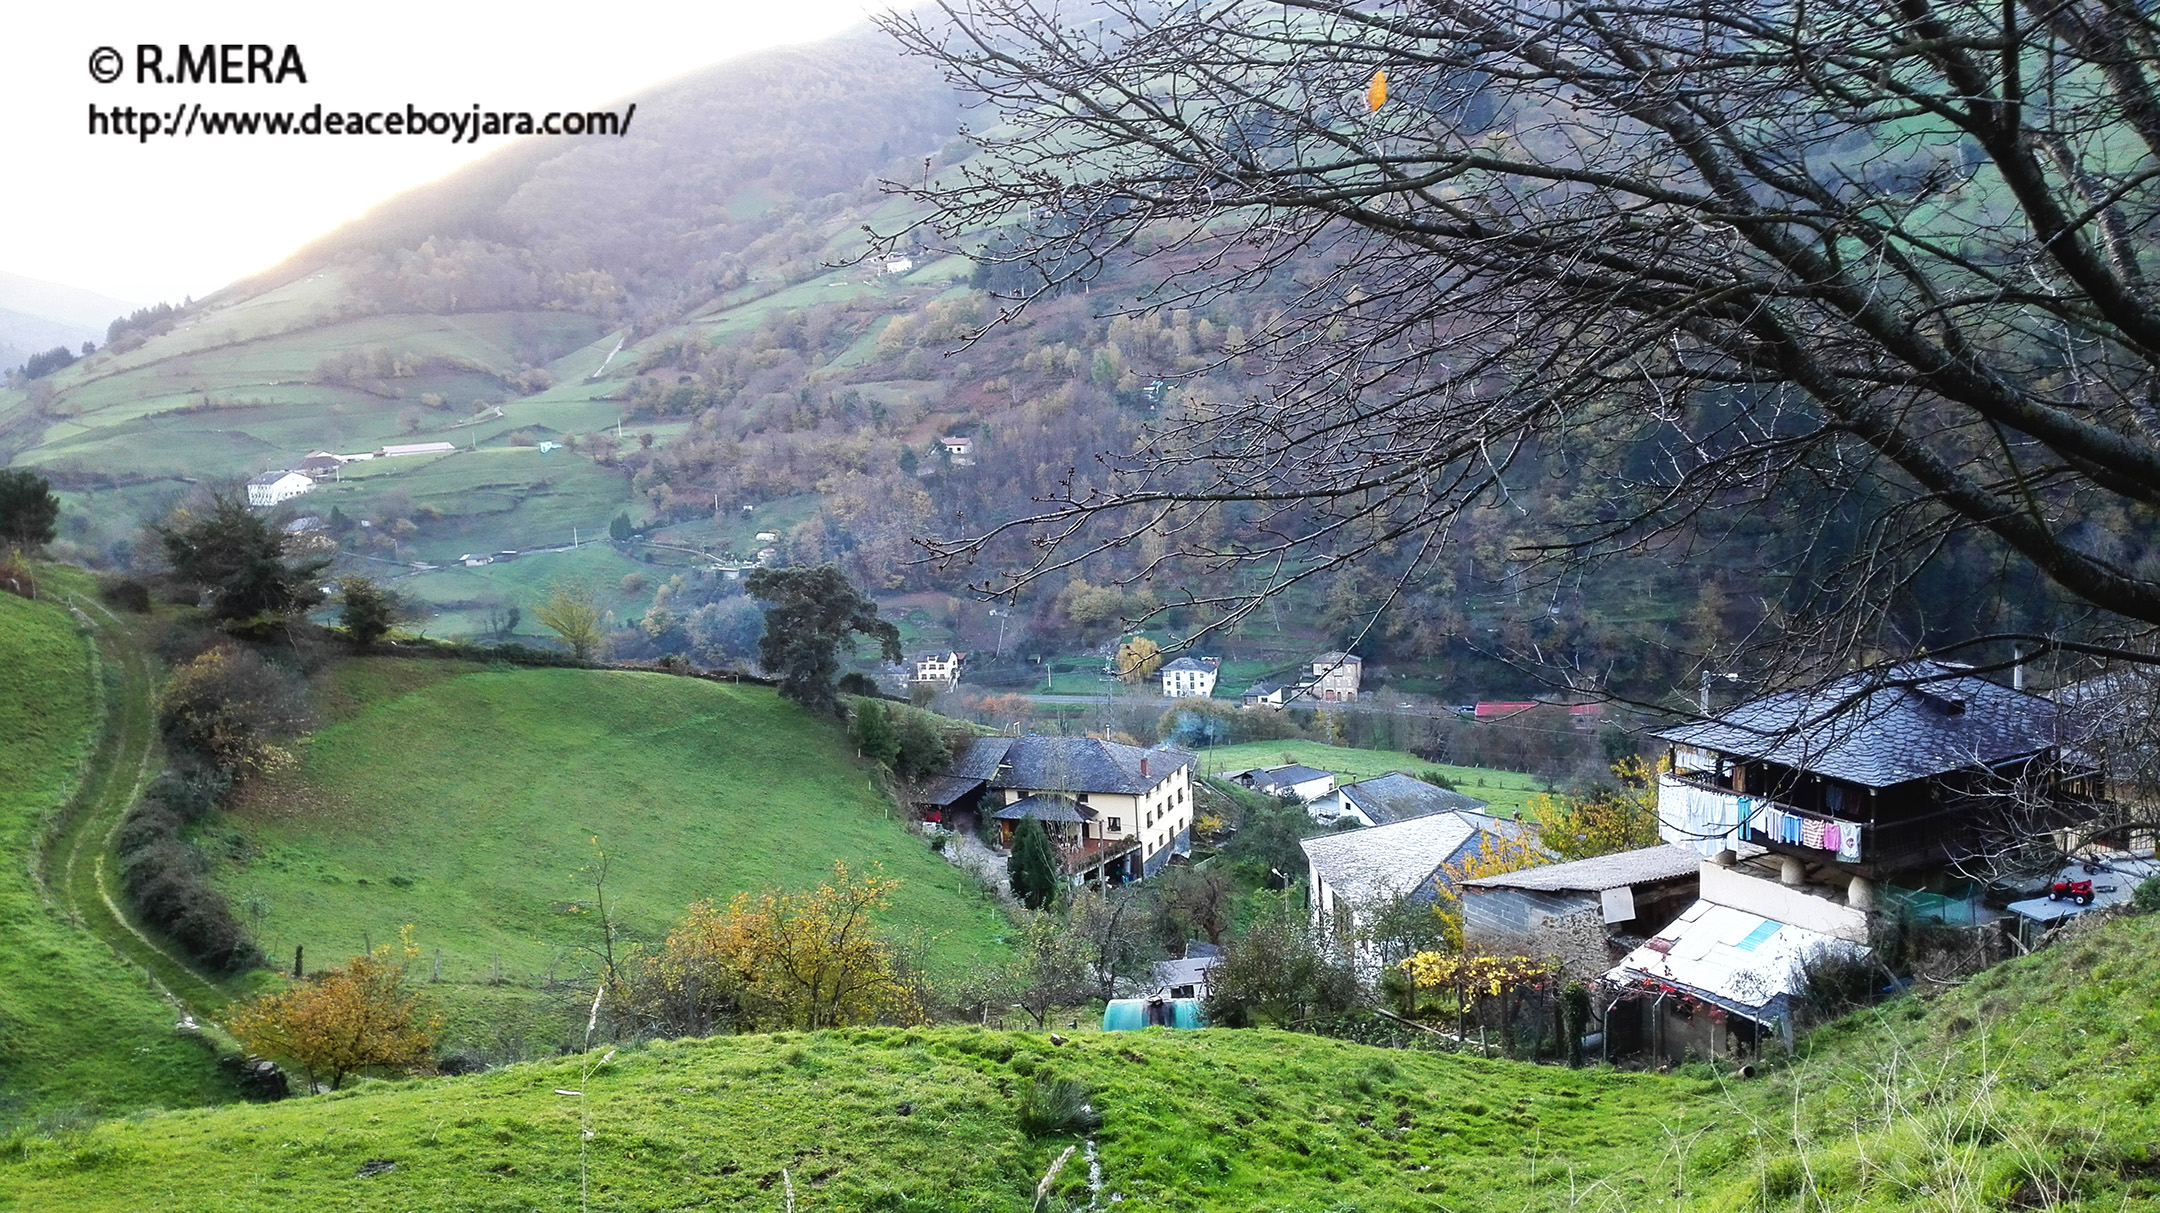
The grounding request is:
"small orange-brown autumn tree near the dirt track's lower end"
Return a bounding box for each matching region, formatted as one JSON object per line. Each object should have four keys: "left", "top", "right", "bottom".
{"left": 229, "top": 928, "right": 443, "bottom": 1090}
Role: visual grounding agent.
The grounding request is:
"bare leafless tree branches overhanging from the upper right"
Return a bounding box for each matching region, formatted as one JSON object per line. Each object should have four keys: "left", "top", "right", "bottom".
{"left": 883, "top": 0, "right": 2160, "bottom": 682}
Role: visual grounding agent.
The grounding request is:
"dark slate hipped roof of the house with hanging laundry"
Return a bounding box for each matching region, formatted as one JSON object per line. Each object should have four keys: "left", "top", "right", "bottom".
{"left": 1655, "top": 660, "right": 2065, "bottom": 788}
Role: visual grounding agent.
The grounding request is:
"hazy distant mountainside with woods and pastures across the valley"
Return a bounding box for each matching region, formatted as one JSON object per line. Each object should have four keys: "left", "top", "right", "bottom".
{"left": 0, "top": 21, "right": 2090, "bottom": 699}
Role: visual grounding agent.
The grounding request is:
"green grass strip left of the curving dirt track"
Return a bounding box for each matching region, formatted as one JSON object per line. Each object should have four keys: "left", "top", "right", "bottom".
{"left": 0, "top": 594, "right": 225, "bottom": 1122}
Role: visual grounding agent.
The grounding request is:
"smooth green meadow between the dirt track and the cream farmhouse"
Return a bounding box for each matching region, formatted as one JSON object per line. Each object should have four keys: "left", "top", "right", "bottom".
{"left": 207, "top": 658, "right": 1002, "bottom": 1040}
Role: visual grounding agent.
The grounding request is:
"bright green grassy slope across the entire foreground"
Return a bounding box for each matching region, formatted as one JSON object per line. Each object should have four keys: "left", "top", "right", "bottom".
{"left": 0, "top": 902, "right": 2160, "bottom": 1213}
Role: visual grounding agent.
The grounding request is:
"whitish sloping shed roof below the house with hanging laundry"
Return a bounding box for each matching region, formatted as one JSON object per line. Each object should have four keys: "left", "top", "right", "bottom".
{"left": 1605, "top": 900, "right": 1866, "bottom": 1017}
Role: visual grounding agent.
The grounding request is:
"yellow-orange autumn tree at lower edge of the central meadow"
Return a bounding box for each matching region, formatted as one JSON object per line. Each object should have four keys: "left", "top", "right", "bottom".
{"left": 613, "top": 863, "right": 922, "bottom": 1036}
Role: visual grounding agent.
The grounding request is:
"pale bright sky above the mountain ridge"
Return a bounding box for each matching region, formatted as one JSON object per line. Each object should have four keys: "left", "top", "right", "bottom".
{"left": 0, "top": 0, "right": 881, "bottom": 302}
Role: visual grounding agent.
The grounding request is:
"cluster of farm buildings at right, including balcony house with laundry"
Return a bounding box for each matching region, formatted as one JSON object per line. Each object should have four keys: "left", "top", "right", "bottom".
{"left": 1140, "top": 663, "right": 2156, "bottom": 1060}
